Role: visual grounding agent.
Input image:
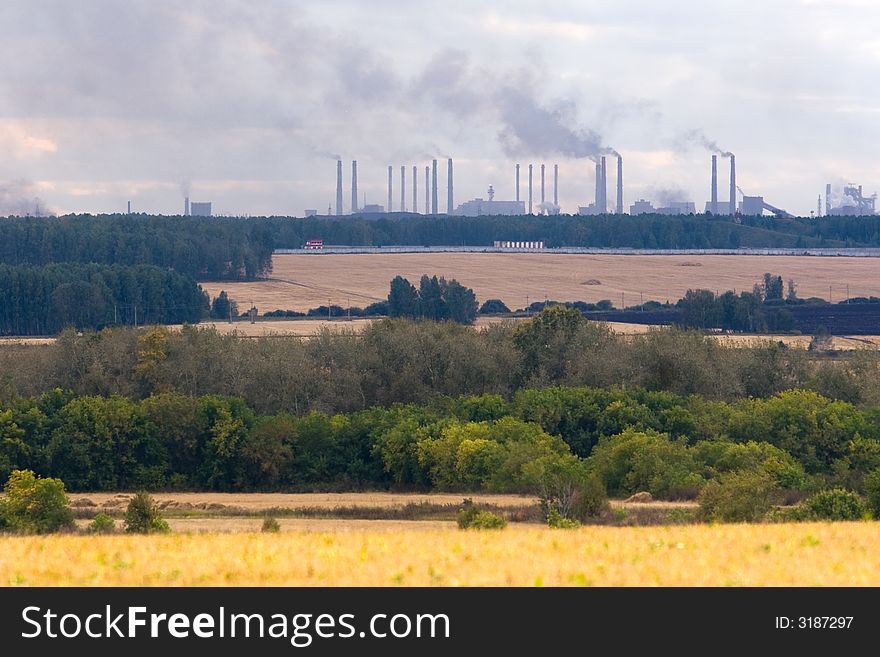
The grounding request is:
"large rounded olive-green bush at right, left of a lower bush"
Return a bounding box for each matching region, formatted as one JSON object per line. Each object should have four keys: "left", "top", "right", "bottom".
{"left": 698, "top": 470, "right": 779, "bottom": 522}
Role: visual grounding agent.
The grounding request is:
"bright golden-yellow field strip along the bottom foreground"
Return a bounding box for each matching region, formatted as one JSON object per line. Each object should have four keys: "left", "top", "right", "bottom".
{"left": 0, "top": 522, "right": 880, "bottom": 586}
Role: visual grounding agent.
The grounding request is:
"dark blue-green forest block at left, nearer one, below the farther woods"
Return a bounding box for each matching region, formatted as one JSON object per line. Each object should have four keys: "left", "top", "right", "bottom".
{"left": 0, "top": 264, "right": 208, "bottom": 335}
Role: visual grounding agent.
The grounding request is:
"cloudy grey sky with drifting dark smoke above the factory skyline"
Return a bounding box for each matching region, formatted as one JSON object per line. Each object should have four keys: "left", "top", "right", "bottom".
{"left": 0, "top": 0, "right": 880, "bottom": 216}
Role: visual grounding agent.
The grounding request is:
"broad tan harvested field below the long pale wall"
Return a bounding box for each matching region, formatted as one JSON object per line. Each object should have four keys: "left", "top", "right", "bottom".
{"left": 202, "top": 253, "right": 880, "bottom": 312}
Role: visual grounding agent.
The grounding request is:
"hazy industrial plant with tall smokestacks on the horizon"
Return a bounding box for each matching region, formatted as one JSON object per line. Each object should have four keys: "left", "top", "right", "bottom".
{"left": 318, "top": 149, "right": 877, "bottom": 218}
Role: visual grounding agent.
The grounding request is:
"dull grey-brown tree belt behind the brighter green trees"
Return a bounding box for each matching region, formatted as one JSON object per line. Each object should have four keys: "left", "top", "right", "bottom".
{"left": 0, "top": 307, "right": 880, "bottom": 415}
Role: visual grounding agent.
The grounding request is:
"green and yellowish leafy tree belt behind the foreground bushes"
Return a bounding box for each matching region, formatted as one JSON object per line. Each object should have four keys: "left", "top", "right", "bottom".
{"left": 0, "top": 387, "right": 880, "bottom": 499}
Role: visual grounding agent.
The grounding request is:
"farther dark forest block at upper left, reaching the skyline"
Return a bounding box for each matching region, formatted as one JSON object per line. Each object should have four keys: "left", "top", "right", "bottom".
{"left": 0, "top": 215, "right": 274, "bottom": 280}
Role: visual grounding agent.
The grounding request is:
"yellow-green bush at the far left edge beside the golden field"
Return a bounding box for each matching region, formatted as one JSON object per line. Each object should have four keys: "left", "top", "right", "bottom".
{"left": 0, "top": 470, "right": 74, "bottom": 534}
